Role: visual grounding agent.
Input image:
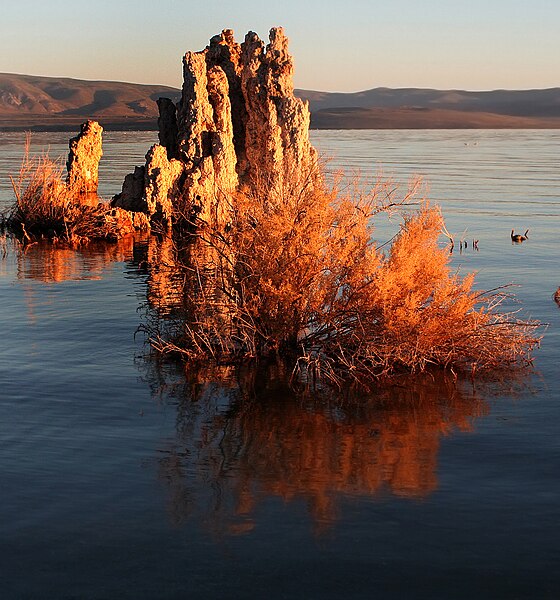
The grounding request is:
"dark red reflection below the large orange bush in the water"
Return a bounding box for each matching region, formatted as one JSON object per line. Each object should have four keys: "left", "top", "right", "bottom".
{"left": 147, "top": 370, "right": 488, "bottom": 534}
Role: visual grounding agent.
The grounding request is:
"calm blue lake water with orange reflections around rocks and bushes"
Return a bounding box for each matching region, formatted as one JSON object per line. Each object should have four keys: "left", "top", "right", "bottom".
{"left": 0, "top": 131, "right": 560, "bottom": 600}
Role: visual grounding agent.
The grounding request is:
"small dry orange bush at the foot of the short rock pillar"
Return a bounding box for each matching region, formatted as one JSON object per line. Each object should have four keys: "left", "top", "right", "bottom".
{"left": 5, "top": 140, "right": 140, "bottom": 242}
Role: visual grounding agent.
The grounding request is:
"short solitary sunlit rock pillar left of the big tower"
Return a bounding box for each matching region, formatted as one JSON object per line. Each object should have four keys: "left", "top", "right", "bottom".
{"left": 66, "top": 121, "right": 103, "bottom": 204}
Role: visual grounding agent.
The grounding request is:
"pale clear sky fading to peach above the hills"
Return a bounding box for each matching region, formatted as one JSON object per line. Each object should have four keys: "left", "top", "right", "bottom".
{"left": 0, "top": 0, "right": 560, "bottom": 92}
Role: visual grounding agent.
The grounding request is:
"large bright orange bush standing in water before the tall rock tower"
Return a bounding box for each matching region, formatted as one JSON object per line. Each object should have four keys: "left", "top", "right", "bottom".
{"left": 144, "top": 159, "right": 537, "bottom": 382}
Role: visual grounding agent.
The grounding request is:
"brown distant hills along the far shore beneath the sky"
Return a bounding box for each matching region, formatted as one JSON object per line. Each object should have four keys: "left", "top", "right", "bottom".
{"left": 0, "top": 74, "right": 560, "bottom": 131}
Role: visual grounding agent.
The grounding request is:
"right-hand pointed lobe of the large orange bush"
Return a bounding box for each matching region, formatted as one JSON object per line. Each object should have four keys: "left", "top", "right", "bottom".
{"left": 322, "top": 204, "right": 538, "bottom": 380}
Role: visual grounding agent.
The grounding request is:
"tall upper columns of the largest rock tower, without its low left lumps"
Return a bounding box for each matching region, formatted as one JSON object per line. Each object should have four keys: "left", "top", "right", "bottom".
{"left": 178, "top": 27, "right": 316, "bottom": 204}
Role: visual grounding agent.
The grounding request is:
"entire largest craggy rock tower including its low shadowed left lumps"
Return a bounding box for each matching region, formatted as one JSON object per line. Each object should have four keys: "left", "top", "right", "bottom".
{"left": 113, "top": 28, "right": 316, "bottom": 230}
